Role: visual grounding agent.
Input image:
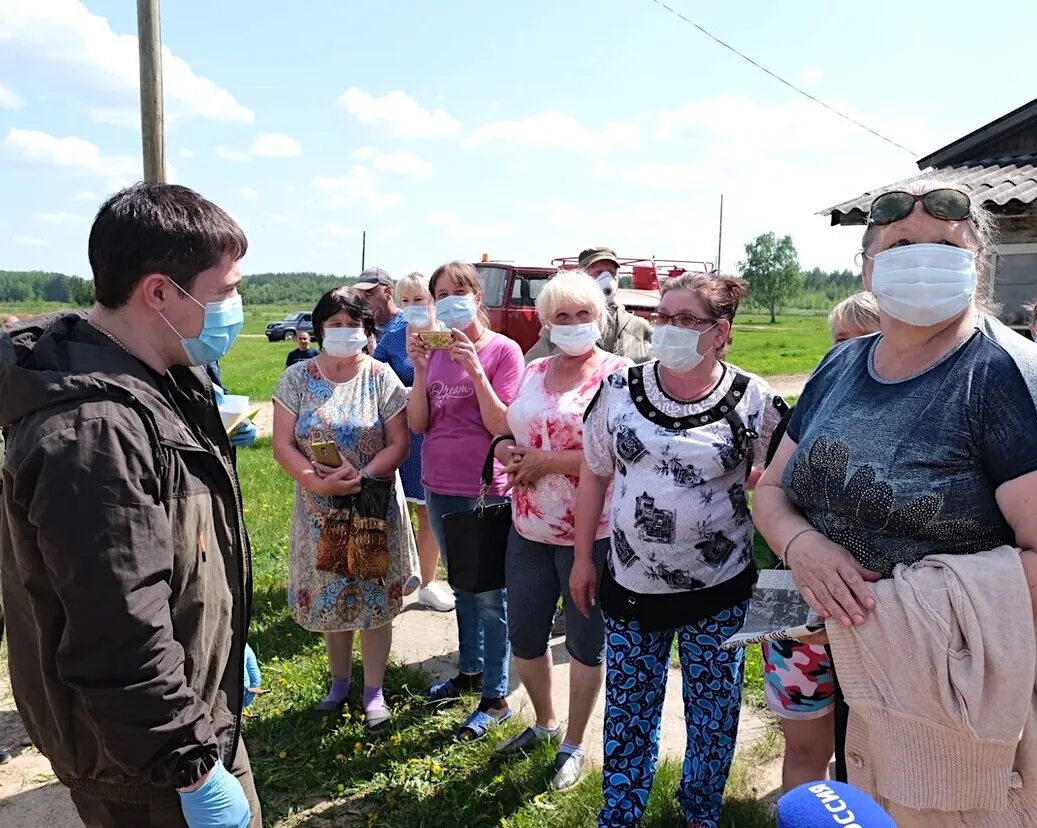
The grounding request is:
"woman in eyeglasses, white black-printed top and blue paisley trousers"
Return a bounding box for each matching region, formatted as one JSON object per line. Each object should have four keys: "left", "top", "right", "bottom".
{"left": 569, "top": 273, "right": 785, "bottom": 828}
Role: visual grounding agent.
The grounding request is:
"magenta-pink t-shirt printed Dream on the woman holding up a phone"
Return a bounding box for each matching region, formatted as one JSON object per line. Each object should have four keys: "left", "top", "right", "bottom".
{"left": 421, "top": 333, "right": 524, "bottom": 497}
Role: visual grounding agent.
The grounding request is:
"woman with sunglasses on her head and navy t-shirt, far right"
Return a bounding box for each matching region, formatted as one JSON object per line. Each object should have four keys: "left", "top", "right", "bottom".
{"left": 754, "top": 181, "right": 1037, "bottom": 826}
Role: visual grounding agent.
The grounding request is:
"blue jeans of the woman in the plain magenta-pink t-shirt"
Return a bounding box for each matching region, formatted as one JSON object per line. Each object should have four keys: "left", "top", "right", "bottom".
{"left": 425, "top": 489, "right": 511, "bottom": 698}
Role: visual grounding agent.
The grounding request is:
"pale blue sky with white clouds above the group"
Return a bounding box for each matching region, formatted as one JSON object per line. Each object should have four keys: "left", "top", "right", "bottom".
{"left": 0, "top": 0, "right": 1037, "bottom": 276}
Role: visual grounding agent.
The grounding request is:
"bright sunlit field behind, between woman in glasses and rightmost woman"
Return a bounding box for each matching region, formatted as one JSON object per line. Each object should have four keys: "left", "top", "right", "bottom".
{"left": 728, "top": 315, "right": 832, "bottom": 377}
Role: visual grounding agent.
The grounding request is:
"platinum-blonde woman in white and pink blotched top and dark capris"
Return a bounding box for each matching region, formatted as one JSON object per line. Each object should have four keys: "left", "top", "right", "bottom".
{"left": 497, "top": 271, "right": 633, "bottom": 790}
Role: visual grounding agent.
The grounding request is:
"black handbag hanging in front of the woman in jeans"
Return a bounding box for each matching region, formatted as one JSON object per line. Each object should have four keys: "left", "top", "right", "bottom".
{"left": 443, "top": 435, "right": 512, "bottom": 592}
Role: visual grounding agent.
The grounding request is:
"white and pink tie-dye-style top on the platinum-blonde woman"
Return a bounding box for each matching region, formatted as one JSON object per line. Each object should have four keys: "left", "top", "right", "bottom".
{"left": 508, "top": 354, "right": 633, "bottom": 546}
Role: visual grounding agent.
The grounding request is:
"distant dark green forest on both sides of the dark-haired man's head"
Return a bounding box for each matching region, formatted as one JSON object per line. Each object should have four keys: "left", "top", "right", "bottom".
{"left": 0, "top": 270, "right": 356, "bottom": 307}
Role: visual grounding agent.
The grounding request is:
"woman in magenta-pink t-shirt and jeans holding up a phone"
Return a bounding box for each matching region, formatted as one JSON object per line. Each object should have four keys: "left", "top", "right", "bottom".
{"left": 407, "top": 261, "right": 523, "bottom": 741}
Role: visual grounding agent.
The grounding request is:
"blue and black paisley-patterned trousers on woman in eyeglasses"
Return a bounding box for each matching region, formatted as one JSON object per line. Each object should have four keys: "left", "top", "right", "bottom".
{"left": 597, "top": 601, "right": 749, "bottom": 828}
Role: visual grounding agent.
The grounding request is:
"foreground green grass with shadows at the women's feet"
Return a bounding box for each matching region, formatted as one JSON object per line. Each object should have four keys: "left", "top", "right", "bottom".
{"left": 237, "top": 440, "right": 773, "bottom": 828}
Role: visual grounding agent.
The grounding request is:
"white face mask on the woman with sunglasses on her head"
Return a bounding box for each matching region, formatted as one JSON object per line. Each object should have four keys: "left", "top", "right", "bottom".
{"left": 871, "top": 244, "right": 977, "bottom": 327}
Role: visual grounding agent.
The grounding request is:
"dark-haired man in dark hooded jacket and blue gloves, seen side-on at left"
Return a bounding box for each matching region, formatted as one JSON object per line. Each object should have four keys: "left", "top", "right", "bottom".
{"left": 0, "top": 184, "right": 261, "bottom": 828}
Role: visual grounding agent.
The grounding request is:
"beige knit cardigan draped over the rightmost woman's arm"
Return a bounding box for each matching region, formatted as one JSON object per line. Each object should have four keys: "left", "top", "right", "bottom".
{"left": 828, "top": 547, "right": 1037, "bottom": 828}
